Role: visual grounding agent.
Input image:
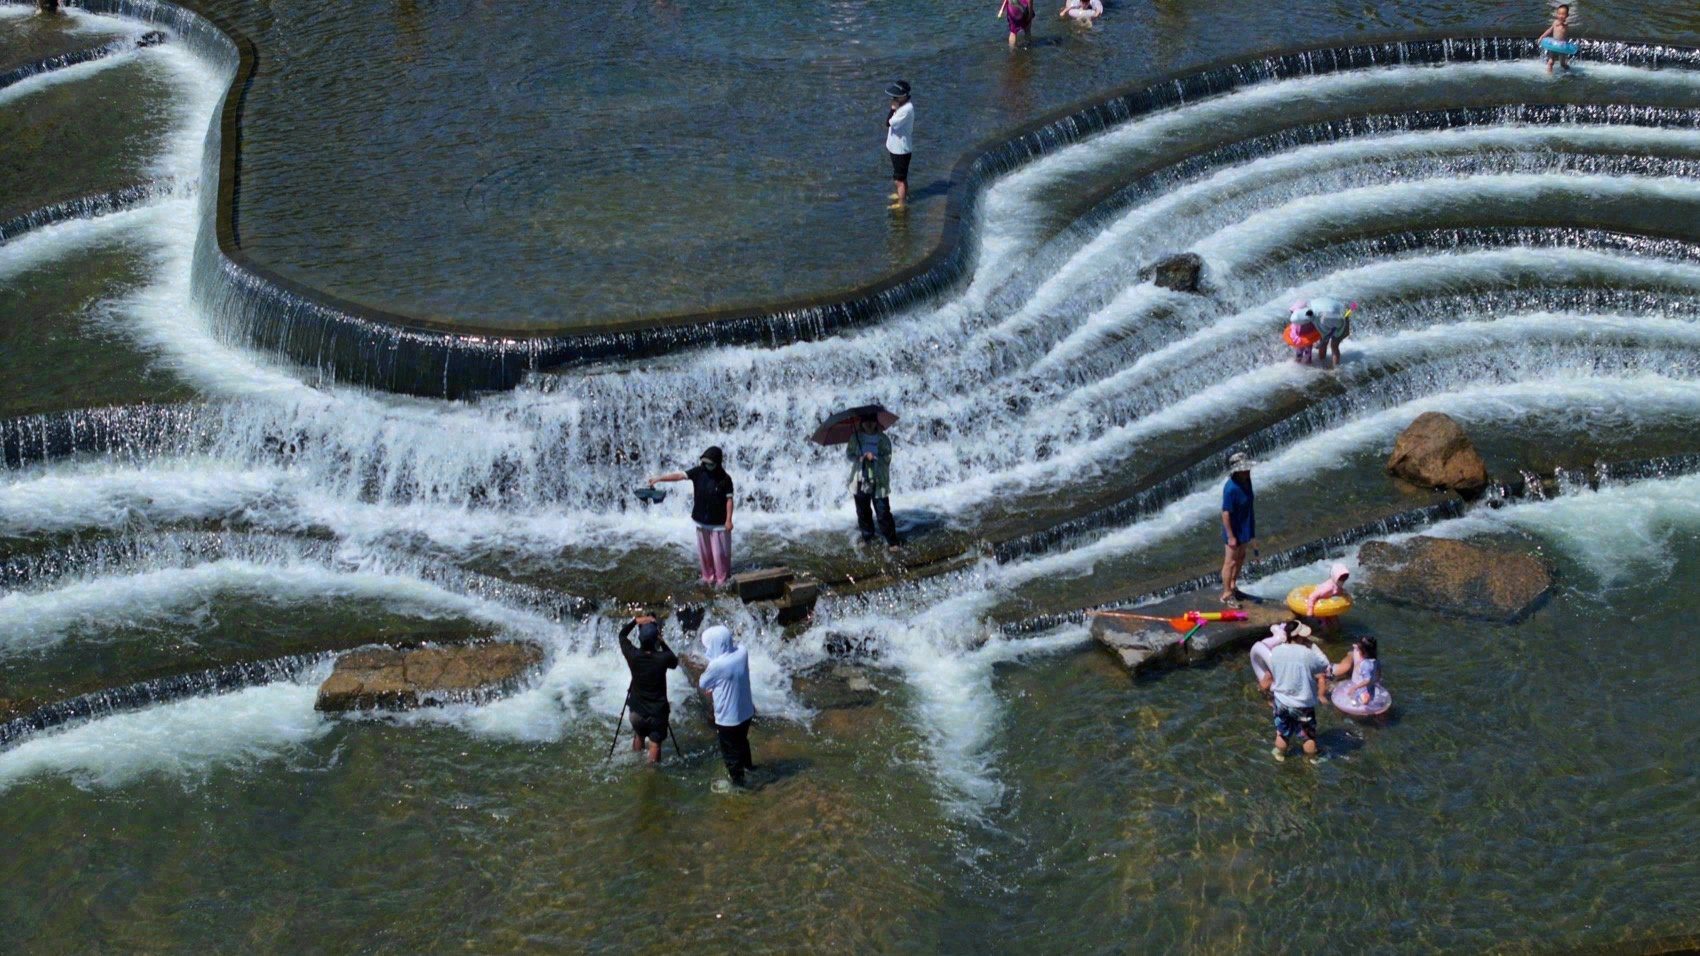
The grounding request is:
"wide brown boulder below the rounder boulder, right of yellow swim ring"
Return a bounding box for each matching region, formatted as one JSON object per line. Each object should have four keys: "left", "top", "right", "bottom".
{"left": 1353, "top": 536, "right": 1552, "bottom": 624}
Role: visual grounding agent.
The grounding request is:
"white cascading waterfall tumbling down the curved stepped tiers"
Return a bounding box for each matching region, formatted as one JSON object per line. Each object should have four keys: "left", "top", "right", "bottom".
{"left": 16, "top": 0, "right": 1700, "bottom": 820}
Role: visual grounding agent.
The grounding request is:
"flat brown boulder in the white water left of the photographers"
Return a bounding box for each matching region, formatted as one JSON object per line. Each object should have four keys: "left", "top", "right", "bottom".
{"left": 313, "top": 643, "right": 542, "bottom": 711}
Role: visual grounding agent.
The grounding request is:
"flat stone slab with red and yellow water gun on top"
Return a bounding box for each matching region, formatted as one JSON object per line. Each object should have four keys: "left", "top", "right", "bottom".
{"left": 1088, "top": 592, "right": 1294, "bottom": 674}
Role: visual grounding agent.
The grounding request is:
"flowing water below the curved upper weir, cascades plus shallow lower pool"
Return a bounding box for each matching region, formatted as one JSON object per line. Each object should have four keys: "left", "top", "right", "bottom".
{"left": 0, "top": 5, "right": 1700, "bottom": 953}
